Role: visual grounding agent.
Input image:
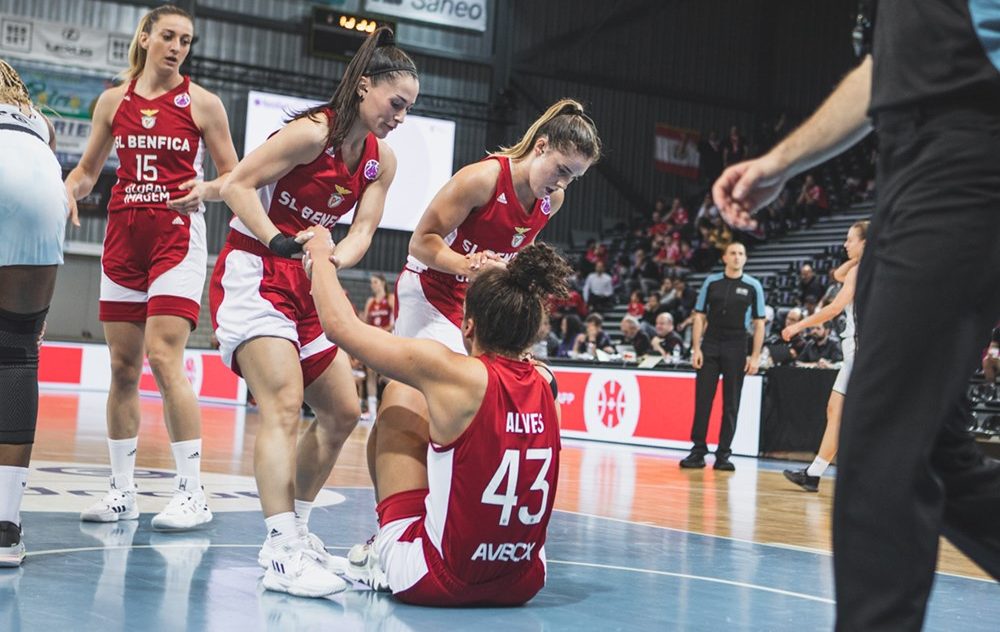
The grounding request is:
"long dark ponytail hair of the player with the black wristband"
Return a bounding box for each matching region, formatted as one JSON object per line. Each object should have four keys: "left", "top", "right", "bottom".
{"left": 289, "top": 26, "right": 418, "bottom": 153}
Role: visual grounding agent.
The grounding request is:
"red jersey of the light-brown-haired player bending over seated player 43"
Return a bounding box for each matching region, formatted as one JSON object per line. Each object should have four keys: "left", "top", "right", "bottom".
{"left": 407, "top": 156, "right": 552, "bottom": 284}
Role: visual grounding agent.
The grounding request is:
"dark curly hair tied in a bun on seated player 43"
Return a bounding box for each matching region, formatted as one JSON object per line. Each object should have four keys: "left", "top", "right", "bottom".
{"left": 465, "top": 242, "right": 573, "bottom": 356}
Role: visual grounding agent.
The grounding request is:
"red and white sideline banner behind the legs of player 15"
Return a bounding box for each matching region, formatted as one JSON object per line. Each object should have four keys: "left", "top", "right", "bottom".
{"left": 38, "top": 342, "right": 247, "bottom": 404}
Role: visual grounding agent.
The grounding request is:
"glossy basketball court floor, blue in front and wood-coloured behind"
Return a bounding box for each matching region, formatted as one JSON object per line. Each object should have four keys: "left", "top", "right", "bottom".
{"left": 0, "top": 392, "right": 1000, "bottom": 632}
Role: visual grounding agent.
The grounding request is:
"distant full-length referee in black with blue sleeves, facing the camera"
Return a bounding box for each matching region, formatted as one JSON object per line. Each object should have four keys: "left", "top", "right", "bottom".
{"left": 681, "top": 242, "right": 764, "bottom": 472}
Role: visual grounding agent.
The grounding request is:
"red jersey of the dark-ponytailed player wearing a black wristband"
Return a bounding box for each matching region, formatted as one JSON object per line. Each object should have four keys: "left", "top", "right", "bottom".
{"left": 229, "top": 110, "right": 380, "bottom": 237}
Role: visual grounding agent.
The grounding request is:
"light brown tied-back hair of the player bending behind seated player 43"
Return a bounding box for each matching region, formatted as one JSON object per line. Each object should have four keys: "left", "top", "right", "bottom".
{"left": 493, "top": 99, "right": 601, "bottom": 162}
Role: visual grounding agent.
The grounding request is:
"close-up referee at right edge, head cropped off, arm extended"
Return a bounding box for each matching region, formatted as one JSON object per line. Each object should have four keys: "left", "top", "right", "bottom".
{"left": 713, "top": 0, "right": 1000, "bottom": 632}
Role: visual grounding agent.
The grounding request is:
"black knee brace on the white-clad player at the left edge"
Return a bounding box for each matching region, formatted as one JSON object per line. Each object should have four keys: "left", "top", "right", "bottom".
{"left": 0, "top": 308, "right": 49, "bottom": 445}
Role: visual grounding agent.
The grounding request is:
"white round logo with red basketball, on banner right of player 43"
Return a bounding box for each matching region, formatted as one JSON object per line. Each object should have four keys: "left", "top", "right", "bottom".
{"left": 583, "top": 370, "right": 641, "bottom": 441}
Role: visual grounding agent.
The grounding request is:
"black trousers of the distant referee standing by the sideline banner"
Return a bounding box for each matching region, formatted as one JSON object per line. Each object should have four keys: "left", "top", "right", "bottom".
{"left": 691, "top": 338, "right": 747, "bottom": 456}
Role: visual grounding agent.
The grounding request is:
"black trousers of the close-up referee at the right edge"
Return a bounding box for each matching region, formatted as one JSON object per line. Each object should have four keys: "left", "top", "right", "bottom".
{"left": 833, "top": 108, "right": 1000, "bottom": 632}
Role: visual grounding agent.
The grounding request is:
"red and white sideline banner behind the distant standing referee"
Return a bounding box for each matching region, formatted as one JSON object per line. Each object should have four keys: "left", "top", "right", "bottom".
{"left": 549, "top": 365, "right": 764, "bottom": 457}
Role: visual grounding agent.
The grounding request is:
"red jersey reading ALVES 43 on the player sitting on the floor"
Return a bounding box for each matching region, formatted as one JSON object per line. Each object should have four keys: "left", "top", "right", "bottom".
{"left": 424, "top": 356, "right": 560, "bottom": 584}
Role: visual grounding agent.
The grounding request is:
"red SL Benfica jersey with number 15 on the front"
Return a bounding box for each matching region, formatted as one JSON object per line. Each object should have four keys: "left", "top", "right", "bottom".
{"left": 108, "top": 77, "right": 204, "bottom": 212}
